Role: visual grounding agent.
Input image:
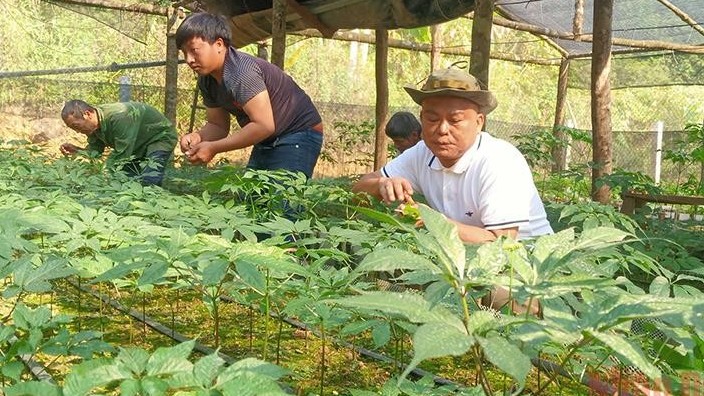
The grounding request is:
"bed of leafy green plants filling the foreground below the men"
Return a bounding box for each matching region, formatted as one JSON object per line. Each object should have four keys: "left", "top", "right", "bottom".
{"left": 0, "top": 147, "right": 704, "bottom": 395}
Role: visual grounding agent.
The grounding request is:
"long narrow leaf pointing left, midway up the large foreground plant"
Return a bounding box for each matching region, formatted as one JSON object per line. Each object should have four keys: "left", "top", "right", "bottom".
{"left": 328, "top": 292, "right": 464, "bottom": 330}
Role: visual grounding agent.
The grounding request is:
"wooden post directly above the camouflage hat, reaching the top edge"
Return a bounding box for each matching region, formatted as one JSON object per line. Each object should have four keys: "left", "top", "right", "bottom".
{"left": 469, "top": 0, "right": 494, "bottom": 89}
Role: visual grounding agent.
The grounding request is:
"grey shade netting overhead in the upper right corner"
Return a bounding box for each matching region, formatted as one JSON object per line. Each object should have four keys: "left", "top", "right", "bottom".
{"left": 496, "top": 0, "right": 704, "bottom": 55}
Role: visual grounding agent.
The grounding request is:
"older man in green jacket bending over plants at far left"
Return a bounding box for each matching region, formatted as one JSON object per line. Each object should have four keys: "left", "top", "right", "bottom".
{"left": 59, "top": 99, "right": 178, "bottom": 186}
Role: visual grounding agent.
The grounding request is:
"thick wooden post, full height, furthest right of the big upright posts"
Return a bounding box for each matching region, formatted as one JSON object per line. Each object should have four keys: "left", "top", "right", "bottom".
{"left": 591, "top": 0, "right": 614, "bottom": 204}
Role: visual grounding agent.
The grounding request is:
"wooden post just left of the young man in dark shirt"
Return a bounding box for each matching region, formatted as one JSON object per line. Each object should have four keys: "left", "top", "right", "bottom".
{"left": 164, "top": 7, "right": 181, "bottom": 126}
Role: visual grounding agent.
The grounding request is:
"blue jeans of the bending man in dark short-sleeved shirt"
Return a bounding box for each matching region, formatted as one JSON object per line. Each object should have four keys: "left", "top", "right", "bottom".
{"left": 247, "top": 129, "right": 323, "bottom": 179}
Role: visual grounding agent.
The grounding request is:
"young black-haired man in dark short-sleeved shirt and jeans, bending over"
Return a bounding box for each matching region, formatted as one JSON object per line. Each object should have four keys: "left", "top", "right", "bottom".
{"left": 176, "top": 12, "right": 323, "bottom": 178}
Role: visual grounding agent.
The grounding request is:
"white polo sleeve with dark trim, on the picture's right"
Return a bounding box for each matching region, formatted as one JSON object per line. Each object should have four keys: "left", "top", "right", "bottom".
{"left": 479, "top": 150, "right": 535, "bottom": 230}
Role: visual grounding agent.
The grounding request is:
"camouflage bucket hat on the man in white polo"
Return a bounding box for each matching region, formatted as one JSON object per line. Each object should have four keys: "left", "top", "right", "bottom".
{"left": 404, "top": 69, "right": 498, "bottom": 114}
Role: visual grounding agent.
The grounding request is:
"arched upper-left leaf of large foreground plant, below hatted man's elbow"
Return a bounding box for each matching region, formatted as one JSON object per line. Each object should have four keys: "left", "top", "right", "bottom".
{"left": 354, "top": 248, "right": 442, "bottom": 274}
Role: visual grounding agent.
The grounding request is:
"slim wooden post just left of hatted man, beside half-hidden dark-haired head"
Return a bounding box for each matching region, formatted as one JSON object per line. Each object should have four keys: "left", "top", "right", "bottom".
{"left": 374, "top": 29, "right": 389, "bottom": 170}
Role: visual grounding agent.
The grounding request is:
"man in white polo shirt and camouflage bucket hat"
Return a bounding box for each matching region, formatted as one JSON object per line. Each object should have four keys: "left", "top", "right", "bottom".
{"left": 352, "top": 69, "right": 552, "bottom": 243}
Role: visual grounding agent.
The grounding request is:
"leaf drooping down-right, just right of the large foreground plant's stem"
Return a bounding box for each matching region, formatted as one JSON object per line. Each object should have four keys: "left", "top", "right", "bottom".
{"left": 477, "top": 337, "right": 531, "bottom": 388}
